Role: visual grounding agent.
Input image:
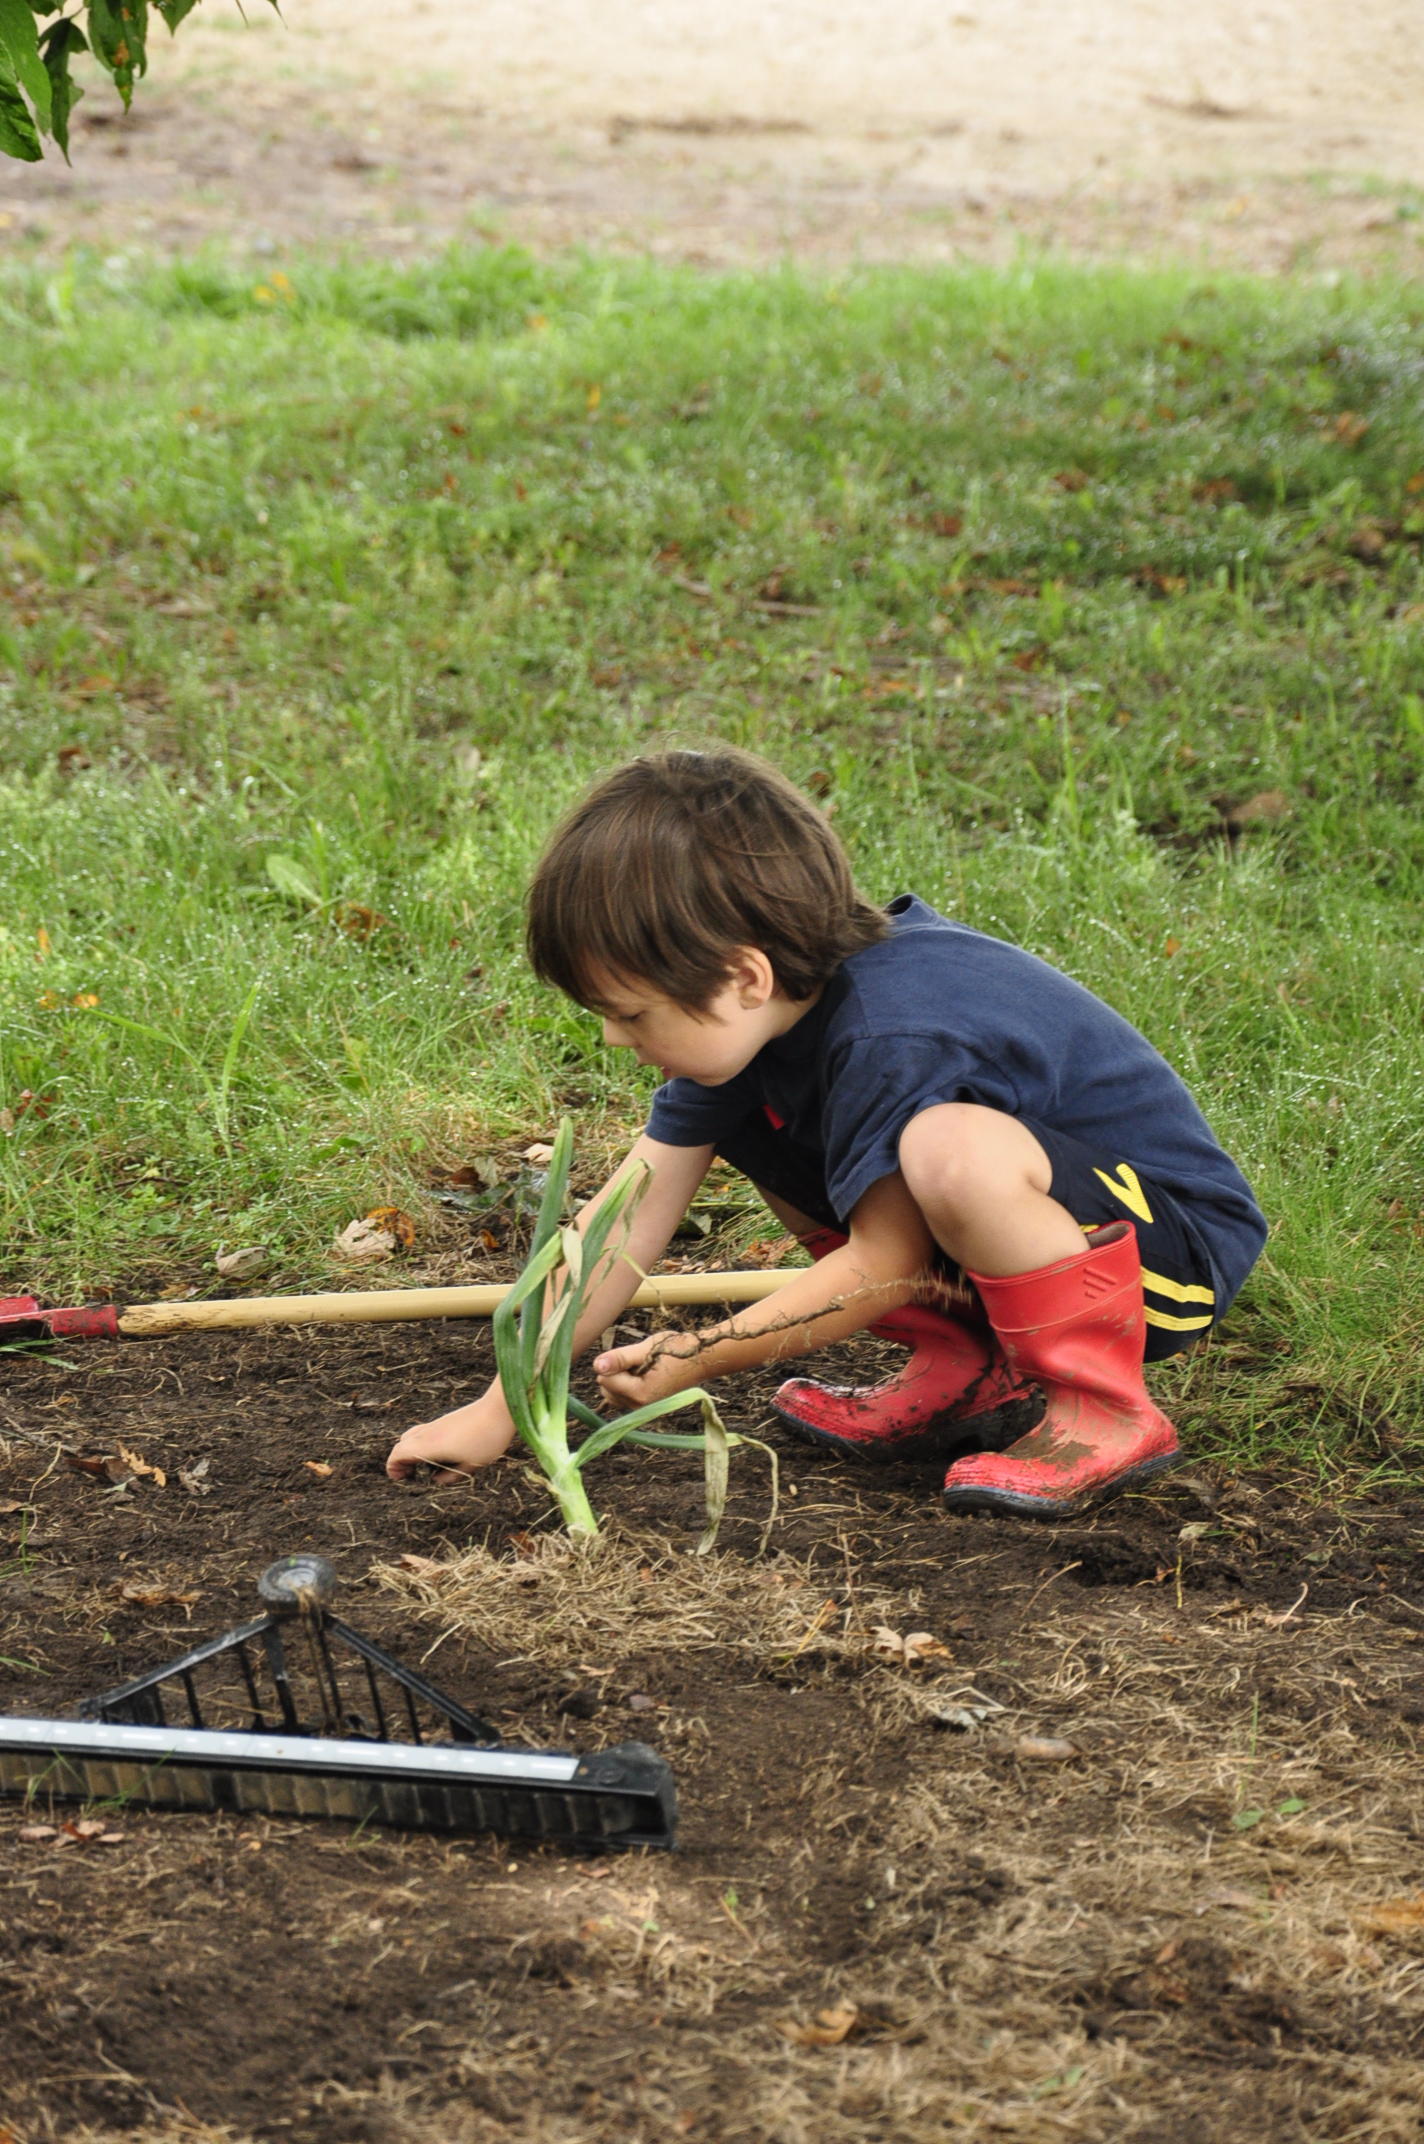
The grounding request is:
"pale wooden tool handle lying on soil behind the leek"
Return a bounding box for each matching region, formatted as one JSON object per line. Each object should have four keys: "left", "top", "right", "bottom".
{"left": 118, "top": 1267, "right": 800, "bottom": 1340}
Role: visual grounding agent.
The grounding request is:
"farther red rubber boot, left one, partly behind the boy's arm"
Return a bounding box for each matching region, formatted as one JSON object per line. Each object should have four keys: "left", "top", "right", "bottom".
{"left": 772, "top": 1229, "right": 1042, "bottom": 1460}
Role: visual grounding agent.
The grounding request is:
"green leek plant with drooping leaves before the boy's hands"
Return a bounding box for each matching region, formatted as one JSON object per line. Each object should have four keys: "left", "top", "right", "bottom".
{"left": 493, "top": 1117, "right": 776, "bottom": 1554}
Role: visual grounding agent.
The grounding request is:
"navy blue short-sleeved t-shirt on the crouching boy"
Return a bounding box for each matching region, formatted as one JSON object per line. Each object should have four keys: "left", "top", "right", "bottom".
{"left": 648, "top": 894, "right": 1265, "bottom": 1316}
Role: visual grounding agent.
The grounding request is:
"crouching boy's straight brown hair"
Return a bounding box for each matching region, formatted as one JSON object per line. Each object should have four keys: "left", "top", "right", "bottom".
{"left": 525, "top": 746, "right": 888, "bottom": 1012}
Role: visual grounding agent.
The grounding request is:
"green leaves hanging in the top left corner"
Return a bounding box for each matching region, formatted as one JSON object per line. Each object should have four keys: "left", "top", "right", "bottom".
{"left": 0, "top": 0, "right": 277, "bottom": 163}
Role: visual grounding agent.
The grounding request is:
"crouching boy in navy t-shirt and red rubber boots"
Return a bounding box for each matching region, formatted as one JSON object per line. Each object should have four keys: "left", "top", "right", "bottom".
{"left": 388, "top": 748, "right": 1265, "bottom": 1518}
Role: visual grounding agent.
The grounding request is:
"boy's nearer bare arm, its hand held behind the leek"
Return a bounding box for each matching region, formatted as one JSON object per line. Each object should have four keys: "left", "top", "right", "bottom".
{"left": 594, "top": 1171, "right": 935, "bottom": 1406}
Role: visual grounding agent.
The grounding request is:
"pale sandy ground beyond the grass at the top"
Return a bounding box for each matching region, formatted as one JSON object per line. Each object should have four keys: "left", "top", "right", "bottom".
{"left": 0, "top": 0, "right": 1424, "bottom": 268}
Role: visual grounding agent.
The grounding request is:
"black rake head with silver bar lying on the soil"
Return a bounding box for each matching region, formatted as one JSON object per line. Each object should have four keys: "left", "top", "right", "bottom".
{"left": 0, "top": 1554, "right": 678, "bottom": 1848}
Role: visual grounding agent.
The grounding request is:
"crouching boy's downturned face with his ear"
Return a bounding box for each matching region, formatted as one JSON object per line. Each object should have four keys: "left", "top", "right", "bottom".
{"left": 596, "top": 948, "right": 806, "bottom": 1087}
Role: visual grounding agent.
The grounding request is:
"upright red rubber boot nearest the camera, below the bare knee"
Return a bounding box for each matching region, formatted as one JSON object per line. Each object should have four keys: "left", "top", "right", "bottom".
{"left": 944, "top": 1220, "right": 1182, "bottom": 1518}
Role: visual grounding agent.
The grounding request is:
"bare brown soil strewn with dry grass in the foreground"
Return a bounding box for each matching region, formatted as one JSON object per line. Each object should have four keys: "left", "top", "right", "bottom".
{"left": 0, "top": 1325, "right": 1424, "bottom": 2144}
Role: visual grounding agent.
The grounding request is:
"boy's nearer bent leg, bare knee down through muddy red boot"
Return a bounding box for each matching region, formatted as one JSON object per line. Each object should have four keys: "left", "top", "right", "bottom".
{"left": 901, "top": 1102, "right": 1210, "bottom": 1518}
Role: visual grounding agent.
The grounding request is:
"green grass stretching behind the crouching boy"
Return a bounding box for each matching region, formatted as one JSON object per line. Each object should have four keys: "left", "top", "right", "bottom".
{"left": 0, "top": 251, "right": 1424, "bottom": 1464}
